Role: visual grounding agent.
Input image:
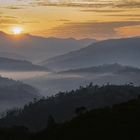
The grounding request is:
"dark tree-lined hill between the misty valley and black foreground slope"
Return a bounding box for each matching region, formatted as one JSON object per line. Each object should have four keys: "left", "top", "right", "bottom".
{"left": 0, "top": 84, "right": 140, "bottom": 130}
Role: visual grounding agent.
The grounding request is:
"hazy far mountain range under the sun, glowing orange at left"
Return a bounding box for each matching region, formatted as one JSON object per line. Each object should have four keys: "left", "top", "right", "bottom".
{"left": 0, "top": 32, "right": 96, "bottom": 62}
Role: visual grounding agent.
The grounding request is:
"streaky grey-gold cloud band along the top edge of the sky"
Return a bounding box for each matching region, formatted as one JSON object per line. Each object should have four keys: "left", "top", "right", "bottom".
{"left": 32, "top": 0, "right": 140, "bottom": 8}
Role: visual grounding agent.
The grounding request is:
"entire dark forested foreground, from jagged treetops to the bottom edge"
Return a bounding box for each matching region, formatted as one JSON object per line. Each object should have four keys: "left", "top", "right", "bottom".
{"left": 0, "top": 83, "right": 140, "bottom": 140}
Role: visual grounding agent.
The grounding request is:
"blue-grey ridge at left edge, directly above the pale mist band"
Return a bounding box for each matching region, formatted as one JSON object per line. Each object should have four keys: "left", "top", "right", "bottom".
{"left": 0, "top": 57, "right": 48, "bottom": 71}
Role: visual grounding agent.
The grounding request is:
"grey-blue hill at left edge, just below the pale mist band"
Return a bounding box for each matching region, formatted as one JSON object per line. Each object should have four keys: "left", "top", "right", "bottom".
{"left": 0, "top": 77, "right": 40, "bottom": 112}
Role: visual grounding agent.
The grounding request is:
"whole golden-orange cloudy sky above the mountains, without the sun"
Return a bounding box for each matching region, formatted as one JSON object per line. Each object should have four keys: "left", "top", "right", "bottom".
{"left": 0, "top": 0, "right": 140, "bottom": 39}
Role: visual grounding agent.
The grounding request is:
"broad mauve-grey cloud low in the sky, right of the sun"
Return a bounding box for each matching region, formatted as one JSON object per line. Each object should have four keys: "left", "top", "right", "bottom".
{"left": 46, "top": 21, "right": 140, "bottom": 39}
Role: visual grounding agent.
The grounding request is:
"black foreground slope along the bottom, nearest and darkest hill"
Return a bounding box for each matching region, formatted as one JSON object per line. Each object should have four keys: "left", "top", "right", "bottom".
{"left": 0, "top": 88, "right": 140, "bottom": 140}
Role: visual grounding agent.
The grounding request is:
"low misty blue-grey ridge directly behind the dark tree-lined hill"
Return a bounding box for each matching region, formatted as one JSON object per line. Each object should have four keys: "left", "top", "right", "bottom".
{"left": 24, "top": 63, "right": 140, "bottom": 96}
